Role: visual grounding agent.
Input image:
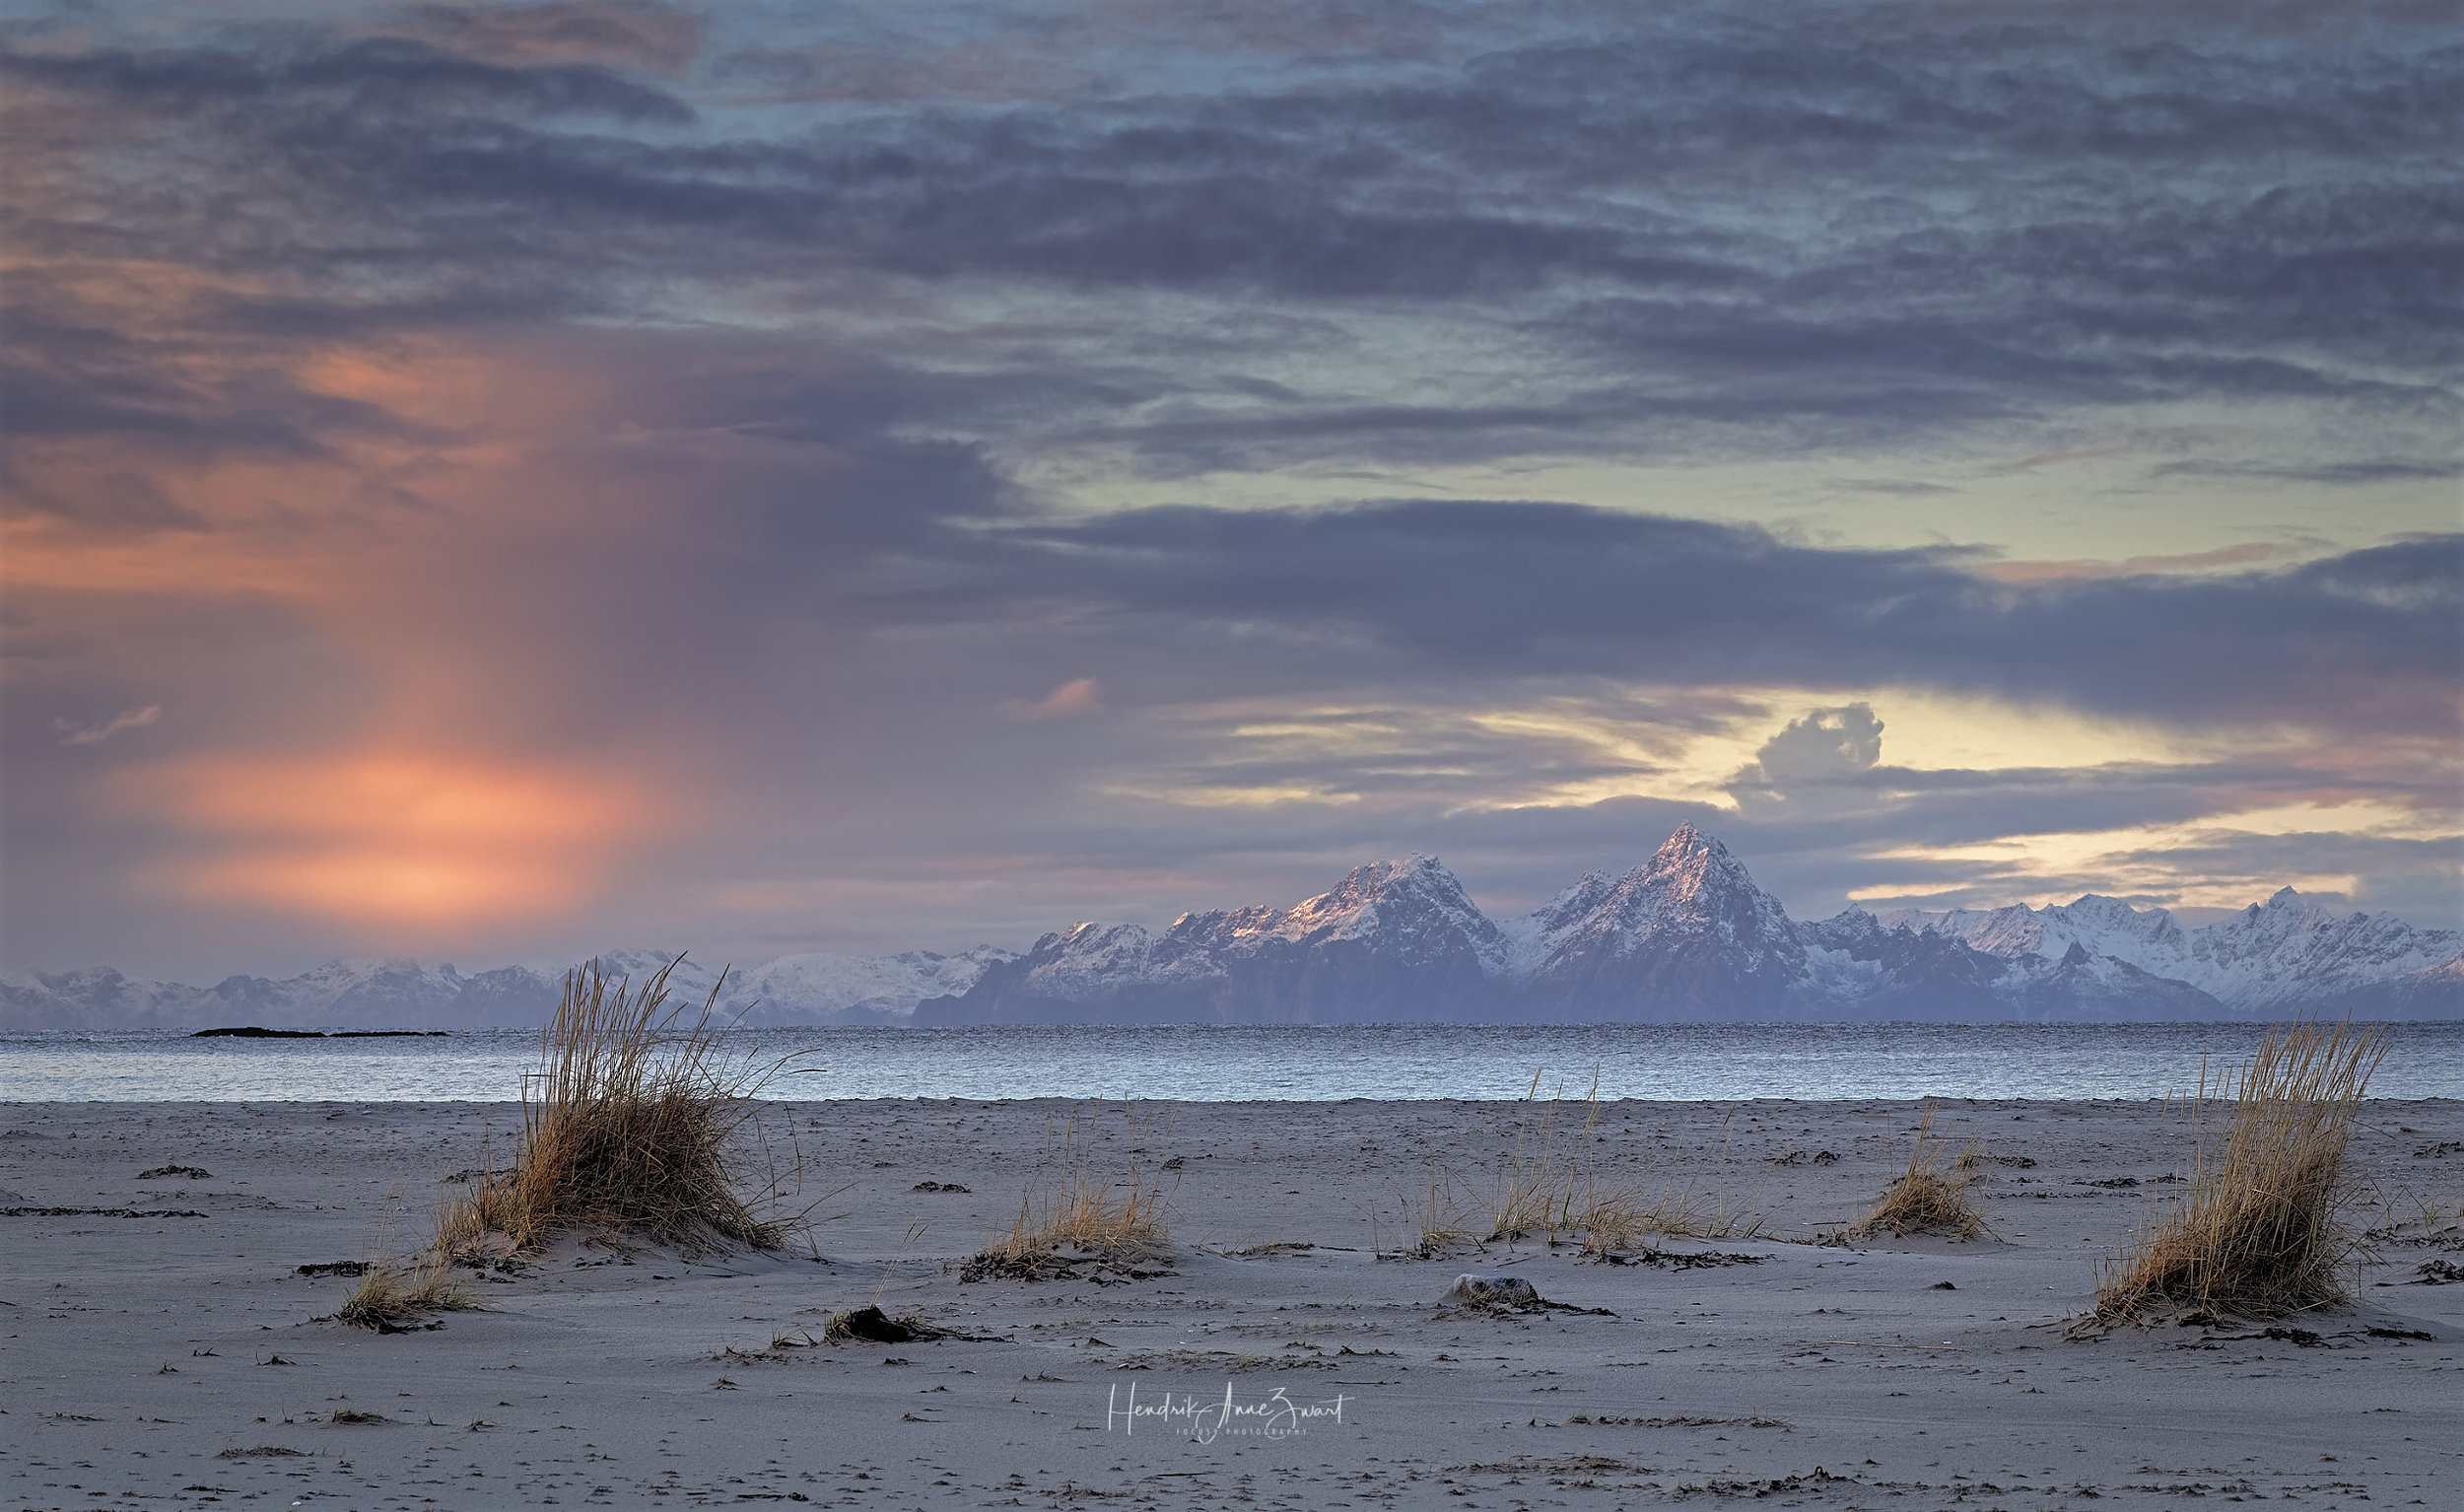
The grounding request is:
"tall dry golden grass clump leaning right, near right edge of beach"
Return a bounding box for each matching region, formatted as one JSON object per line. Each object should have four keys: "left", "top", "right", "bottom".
{"left": 2085, "top": 1024, "right": 2388, "bottom": 1328}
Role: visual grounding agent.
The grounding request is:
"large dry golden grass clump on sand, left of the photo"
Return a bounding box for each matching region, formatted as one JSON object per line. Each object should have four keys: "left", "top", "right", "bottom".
{"left": 437, "top": 958, "right": 801, "bottom": 1254}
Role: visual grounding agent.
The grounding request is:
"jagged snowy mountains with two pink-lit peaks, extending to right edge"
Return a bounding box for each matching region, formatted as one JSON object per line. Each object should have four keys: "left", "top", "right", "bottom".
{"left": 915, "top": 825, "right": 2464, "bottom": 1024}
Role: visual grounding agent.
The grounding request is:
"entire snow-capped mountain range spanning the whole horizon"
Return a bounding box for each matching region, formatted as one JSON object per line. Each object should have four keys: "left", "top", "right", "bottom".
{"left": 0, "top": 825, "right": 2464, "bottom": 1029}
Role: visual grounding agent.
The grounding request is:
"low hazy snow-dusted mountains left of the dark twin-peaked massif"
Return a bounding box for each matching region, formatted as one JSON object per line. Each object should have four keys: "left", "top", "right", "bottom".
{"left": 0, "top": 945, "right": 1013, "bottom": 1029}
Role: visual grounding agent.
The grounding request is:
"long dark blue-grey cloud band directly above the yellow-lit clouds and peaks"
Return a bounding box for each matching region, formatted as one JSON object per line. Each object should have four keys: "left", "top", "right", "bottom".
{"left": 907, "top": 500, "right": 2464, "bottom": 731}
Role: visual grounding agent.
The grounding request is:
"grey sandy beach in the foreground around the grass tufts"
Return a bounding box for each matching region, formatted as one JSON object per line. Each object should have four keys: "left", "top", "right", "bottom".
{"left": 0, "top": 1101, "right": 2464, "bottom": 1510}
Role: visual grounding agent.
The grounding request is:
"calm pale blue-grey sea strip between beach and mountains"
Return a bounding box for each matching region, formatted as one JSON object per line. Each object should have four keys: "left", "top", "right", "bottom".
{"left": 0, "top": 1022, "right": 2464, "bottom": 1103}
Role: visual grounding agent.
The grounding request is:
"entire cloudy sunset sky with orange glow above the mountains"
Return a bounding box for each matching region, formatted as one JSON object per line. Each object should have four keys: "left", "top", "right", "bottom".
{"left": 0, "top": 0, "right": 2464, "bottom": 980}
